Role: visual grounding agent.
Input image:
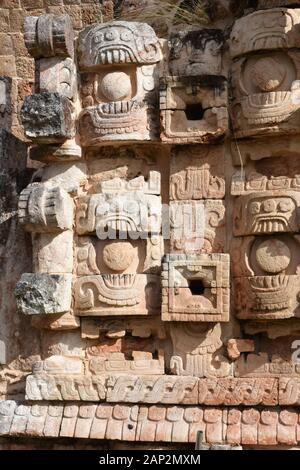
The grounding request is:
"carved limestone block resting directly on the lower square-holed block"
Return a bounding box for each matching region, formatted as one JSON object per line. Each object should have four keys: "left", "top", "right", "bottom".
{"left": 170, "top": 199, "right": 226, "bottom": 253}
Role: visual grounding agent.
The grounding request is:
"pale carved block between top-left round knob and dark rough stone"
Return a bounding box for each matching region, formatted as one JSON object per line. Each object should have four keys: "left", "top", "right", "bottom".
{"left": 36, "top": 57, "right": 77, "bottom": 100}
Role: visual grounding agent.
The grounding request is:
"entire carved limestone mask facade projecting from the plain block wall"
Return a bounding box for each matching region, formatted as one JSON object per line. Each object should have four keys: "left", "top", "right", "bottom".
{"left": 0, "top": 2, "right": 300, "bottom": 445}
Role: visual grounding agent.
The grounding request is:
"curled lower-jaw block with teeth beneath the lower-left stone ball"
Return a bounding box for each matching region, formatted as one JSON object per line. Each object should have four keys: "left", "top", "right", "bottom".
{"left": 75, "top": 273, "right": 161, "bottom": 316}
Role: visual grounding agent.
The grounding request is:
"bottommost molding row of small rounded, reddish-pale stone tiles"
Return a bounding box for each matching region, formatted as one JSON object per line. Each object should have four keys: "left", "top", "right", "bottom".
{"left": 0, "top": 400, "right": 300, "bottom": 446}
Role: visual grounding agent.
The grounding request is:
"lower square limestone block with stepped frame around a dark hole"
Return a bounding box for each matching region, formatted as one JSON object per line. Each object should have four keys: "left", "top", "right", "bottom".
{"left": 162, "top": 254, "right": 229, "bottom": 322}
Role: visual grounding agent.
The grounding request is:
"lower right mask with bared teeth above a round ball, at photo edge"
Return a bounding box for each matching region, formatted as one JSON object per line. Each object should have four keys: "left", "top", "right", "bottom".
{"left": 231, "top": 157, "right": 300, "bottom": 320}
